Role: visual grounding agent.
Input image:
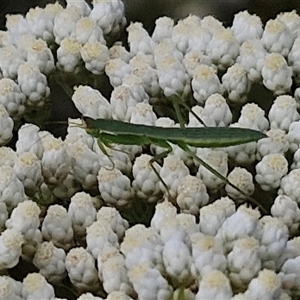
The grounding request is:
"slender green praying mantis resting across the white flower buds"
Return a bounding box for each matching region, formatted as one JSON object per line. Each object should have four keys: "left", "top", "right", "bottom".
{"left": 83, "top": 117, "right": 266, "bottom": 211}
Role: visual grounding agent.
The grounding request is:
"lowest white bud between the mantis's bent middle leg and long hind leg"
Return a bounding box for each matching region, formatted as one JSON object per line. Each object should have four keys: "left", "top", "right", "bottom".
{"left": 176, "top": 175, "right": 209, "bottom": 216}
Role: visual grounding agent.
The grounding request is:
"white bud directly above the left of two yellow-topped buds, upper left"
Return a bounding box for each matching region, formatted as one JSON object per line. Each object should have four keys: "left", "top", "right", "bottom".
{"left": 53, "top": 5, "right": 82, "bottom": 44}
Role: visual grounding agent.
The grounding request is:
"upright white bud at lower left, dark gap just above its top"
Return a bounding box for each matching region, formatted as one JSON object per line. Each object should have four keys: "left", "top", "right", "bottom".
{"left": 42, "top": 204, "right": 74, "bottom": 250}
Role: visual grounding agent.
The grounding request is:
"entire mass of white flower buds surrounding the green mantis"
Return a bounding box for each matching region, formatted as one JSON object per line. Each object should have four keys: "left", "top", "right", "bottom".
{"left": 0, "top": 0, "right": 300, "bottom": 300}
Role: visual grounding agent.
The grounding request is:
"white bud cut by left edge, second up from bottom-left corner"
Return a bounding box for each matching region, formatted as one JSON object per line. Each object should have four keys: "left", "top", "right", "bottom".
{"left": 0, "top": 229, "right": 24, "bottom": 270}
